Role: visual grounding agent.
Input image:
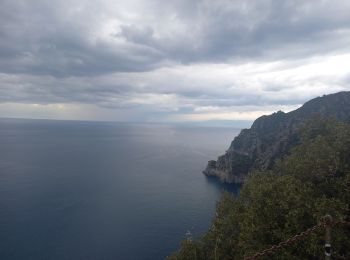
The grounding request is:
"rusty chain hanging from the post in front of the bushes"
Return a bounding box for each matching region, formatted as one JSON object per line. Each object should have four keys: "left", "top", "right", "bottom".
{"left": 244, "top": 220, "right": 350, "bottom": 260}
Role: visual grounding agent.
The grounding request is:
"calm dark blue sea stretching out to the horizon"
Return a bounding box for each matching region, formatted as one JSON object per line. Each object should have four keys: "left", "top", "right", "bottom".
{"left": 0, "top": 119, "right": 238, "bottom": 260}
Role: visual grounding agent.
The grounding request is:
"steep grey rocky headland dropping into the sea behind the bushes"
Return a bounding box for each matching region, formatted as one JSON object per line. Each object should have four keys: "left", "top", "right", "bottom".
{"left": 203, "top": 92, "right": 350, "bottom": 183}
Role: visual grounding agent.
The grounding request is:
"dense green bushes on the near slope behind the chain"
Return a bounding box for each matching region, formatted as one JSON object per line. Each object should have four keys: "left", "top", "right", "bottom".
{"left": 169, "top": 118, "right": 350, "bottom": 260}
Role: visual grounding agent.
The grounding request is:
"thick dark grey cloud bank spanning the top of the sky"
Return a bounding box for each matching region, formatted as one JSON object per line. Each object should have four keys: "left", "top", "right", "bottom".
{"left": 0, "top": 0, "right": 350, "bottom": 77}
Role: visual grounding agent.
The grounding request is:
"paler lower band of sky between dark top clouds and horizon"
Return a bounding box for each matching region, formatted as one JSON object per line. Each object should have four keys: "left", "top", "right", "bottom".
{"left": 0, "top": 54, "right": 350, "bottom": 125}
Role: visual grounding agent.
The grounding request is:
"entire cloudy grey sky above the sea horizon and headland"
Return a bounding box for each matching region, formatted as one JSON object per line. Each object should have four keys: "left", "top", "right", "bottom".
{"left": 0, "top": 0, "right": 350, "bottom": 125}
